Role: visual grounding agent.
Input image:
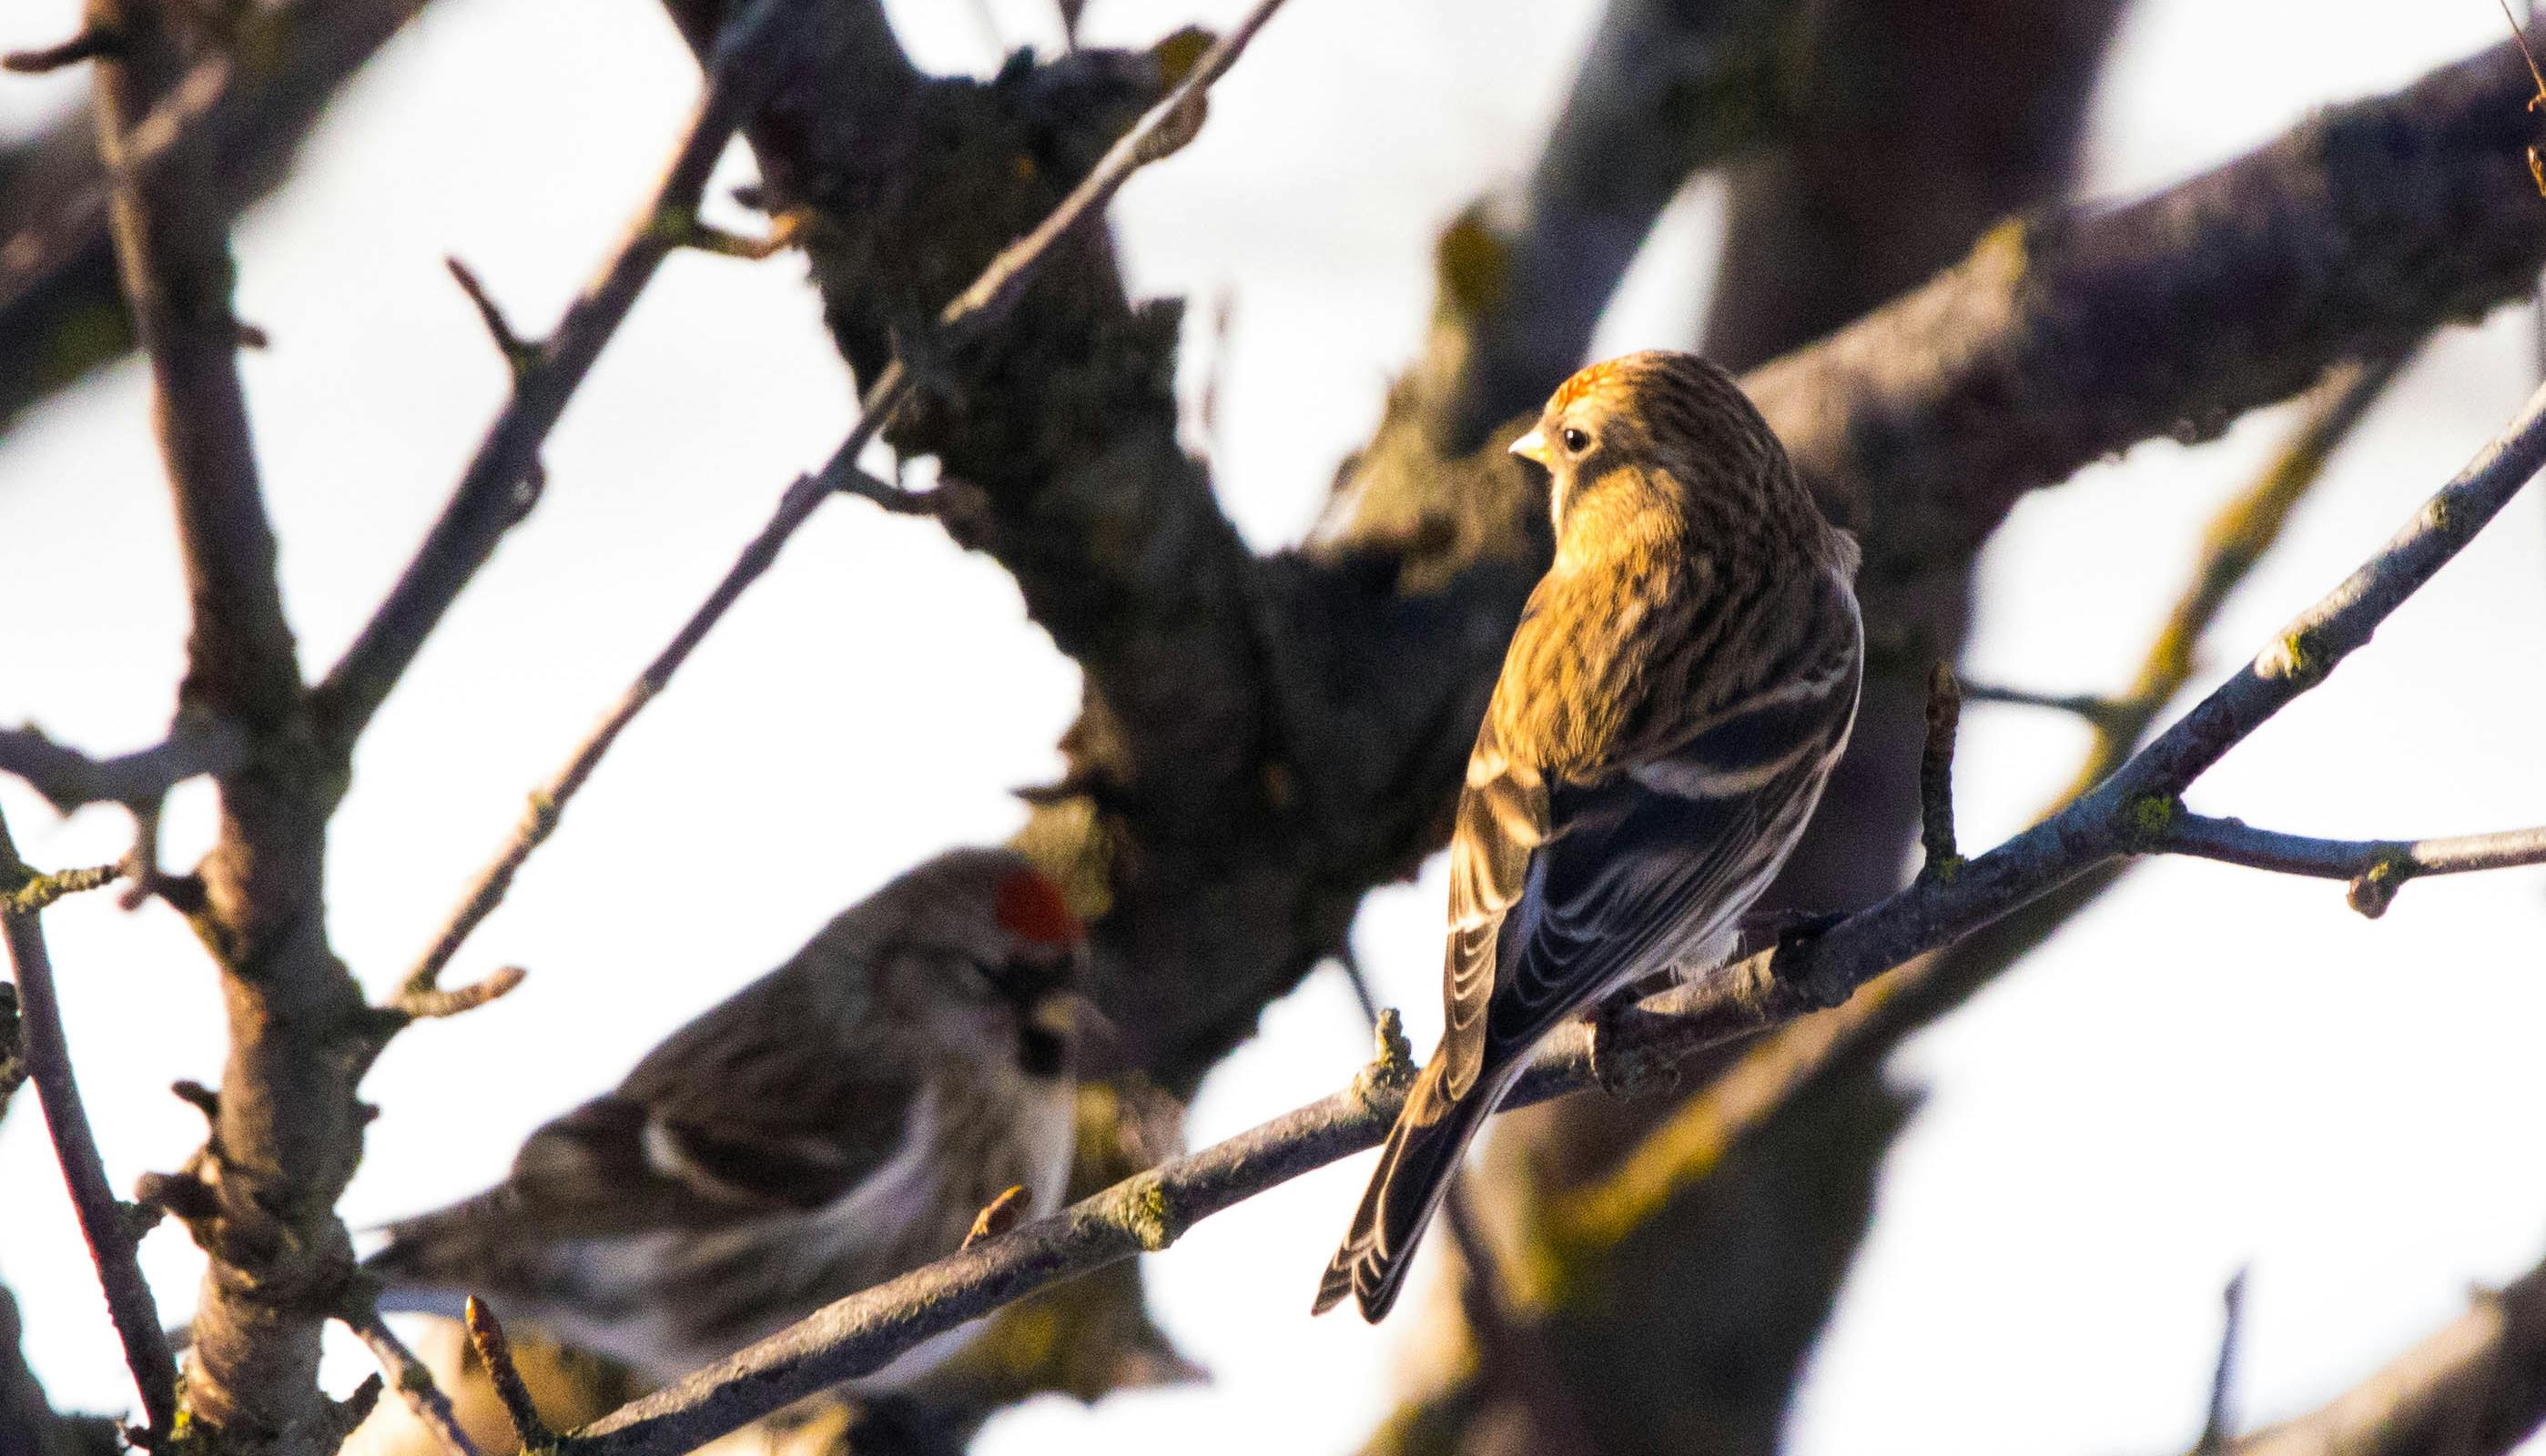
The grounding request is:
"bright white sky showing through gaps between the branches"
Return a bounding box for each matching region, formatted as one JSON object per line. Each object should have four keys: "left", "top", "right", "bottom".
{"left": 0, "top": 0, "right": 2546, "bottom": 1456}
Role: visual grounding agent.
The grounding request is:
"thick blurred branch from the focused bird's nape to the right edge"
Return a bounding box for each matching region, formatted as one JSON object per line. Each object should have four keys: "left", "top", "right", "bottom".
{"left": 1744, "top": 44, "right": 2546, "bottom": 575}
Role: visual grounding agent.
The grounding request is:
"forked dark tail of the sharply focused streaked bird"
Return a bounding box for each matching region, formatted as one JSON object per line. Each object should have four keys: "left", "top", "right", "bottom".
{"left": 1311, "top": 1057, "right": 1510, "bottom": 1324}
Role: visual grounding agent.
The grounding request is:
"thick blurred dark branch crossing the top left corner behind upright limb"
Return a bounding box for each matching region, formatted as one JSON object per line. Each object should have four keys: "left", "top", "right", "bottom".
{"left": 0, "top": 0, "right": 422, "bottom": 422}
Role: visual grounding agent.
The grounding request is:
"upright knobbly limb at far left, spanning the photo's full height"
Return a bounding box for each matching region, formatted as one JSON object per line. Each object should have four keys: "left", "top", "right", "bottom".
{"left": 86, "top": 0, "right": 377, "bottom": 1456}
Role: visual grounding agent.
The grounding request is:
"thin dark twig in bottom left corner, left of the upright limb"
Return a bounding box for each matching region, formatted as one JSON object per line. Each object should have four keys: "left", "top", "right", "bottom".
{"left": 0, "top": 820, "right": 176, "bottom": 1446}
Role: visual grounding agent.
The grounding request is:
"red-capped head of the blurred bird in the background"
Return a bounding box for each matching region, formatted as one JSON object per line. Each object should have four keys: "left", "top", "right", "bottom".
{"left": 878, "top": 850, "right": 1087, "bottom": 1077}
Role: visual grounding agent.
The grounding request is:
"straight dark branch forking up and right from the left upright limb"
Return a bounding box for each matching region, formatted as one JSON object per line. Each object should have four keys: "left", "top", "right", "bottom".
{"left": 319, "top": 0, "right": 812, "bottom": 753}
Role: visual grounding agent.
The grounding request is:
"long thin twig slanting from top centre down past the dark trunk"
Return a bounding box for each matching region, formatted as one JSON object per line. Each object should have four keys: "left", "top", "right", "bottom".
{"left": 405, "top": 0, "right": 1281, "bottom": 996}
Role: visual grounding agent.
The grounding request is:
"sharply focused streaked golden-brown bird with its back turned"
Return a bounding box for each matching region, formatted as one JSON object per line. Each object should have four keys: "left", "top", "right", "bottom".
{"left": 1316, "top": 351, "right": 1863, "bottom": 1321}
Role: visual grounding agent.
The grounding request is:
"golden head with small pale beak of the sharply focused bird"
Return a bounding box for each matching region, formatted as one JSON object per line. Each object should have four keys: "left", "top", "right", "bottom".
{"left": 1512, "top": 349, "right": 1828, "bottom": 575}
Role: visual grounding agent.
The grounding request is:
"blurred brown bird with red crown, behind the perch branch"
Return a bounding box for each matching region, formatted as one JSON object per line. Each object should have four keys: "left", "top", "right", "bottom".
{"left": 370, "top": 850, "right": 1085, "bottom": 1387}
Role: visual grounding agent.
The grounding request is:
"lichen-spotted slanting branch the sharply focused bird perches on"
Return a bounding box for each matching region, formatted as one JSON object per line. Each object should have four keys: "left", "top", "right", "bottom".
{"left": 563, "top": 369, "right": 2546, "bottom": 1456}
